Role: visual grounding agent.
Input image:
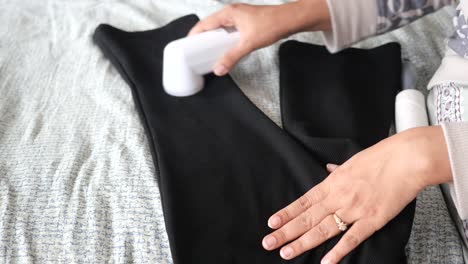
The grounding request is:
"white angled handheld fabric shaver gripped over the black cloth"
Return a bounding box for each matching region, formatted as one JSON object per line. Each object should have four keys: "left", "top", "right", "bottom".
{"left": 163, "top": 28, "right": 240, "bottom": 96}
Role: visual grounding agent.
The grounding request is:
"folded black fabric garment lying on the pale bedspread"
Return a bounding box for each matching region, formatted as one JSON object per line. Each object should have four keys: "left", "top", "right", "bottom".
{"left": 94, "top": 15, "right": 414, "bottom": 264}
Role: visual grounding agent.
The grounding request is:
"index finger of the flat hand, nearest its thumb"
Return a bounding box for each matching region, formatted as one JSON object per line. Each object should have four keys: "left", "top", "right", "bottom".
{"left": 268, "top": 183, "right": 329, "bottom": 229}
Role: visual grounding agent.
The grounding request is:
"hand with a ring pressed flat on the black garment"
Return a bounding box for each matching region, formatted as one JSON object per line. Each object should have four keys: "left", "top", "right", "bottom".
{"left": 262, "top": 127, "right": 452, "bottom": 264}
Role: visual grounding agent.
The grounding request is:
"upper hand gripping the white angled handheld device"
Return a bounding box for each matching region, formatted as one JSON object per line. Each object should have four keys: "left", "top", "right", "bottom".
{"left": 189, "top": 0, "right": 330, "bottom": 76}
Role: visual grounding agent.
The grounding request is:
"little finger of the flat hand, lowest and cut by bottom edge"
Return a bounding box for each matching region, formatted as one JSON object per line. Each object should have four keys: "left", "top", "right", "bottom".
{"left": 321, "top": 220, "right": 376, "bottom": 264}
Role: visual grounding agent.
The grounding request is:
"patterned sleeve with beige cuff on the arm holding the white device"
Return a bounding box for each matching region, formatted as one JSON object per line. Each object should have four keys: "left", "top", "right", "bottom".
{"left": 323, "top": 0, "right": 456, "bottom": 52}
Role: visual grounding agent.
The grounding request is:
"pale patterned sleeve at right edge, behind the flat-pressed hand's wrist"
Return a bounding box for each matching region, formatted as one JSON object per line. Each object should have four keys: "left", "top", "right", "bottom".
{"left": 427, "top": 0, "right": 468, "bottom": 225}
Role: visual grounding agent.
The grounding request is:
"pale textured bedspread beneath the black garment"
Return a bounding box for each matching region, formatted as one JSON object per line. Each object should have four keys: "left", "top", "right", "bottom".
{"left": 0, "top": 0, "right": 463, "bottom": 263}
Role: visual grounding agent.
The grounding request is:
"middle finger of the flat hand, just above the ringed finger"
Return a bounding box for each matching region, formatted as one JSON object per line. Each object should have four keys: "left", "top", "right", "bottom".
{"left": 262, "top": 203, "right": 330, "bottom": 250}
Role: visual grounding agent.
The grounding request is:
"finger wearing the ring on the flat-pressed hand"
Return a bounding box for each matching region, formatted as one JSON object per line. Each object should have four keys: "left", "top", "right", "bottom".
{"left": 280, "top": 215, "right": 341, "bottom": 260}
